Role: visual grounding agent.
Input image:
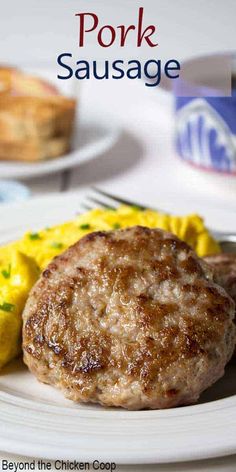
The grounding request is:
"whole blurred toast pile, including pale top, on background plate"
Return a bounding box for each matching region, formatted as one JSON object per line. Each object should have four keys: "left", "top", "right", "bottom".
{"left": 0, "top": 67, "right": 76, "bottom": 162}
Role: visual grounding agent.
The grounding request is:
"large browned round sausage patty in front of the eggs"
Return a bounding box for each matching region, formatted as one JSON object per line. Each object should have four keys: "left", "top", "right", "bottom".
{"left": 23, "top": 227, "right": 235, "bottom": 409}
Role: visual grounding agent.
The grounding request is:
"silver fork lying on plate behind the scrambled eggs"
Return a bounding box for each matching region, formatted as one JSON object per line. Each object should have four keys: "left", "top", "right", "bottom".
{"left": 82, "top": 187, "right": 236, "bottom": 253}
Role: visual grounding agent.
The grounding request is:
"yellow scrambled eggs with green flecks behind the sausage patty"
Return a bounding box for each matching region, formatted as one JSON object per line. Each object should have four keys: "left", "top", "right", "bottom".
{"left": 0, "top": 206, "right": 220, "bottom": 368}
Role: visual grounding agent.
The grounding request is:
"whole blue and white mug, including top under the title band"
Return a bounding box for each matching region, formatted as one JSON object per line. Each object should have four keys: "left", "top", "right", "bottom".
{"left": 174, "top": 55, "right": 236, "bottom": 175}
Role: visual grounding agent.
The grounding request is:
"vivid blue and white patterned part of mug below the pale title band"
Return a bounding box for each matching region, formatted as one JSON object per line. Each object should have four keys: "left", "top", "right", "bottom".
{"left": 176, "top": 96, "right": 236, "bottom": 173}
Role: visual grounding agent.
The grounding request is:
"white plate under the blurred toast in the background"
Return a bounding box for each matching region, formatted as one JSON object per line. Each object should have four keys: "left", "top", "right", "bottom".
{"left": 0, "top": 115, "right": 120, "bottom": 179}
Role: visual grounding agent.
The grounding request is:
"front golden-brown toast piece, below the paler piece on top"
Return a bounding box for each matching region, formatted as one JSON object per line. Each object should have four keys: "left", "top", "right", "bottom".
{"left": 0, "top": 95, "right": 76, "bottom": 161}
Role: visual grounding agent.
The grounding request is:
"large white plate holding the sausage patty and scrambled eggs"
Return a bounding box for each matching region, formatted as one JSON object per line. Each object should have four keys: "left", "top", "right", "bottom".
{"left": 0, "top": 193, "right": 236, "bottom": 464}
